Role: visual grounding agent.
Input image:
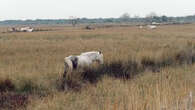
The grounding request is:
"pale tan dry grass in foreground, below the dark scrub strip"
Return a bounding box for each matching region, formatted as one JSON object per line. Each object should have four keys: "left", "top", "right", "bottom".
{"left": 28, "top": 66, "right": 195, "bottom": 110}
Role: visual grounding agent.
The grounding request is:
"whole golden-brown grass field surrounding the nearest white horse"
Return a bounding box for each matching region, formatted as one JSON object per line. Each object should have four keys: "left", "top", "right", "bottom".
{"left": 0, "top": 24, "right": 195, "bottom": 110}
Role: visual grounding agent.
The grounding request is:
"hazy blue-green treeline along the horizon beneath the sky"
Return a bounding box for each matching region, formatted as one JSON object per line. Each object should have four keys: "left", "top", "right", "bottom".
{"left": 0, "top": 14, "right": 195, "bottom": 25}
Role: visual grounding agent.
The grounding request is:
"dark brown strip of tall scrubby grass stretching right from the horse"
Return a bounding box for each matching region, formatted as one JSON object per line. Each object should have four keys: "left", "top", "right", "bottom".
{"left": 61, "top": 43, "right": 195, "bottom": 89}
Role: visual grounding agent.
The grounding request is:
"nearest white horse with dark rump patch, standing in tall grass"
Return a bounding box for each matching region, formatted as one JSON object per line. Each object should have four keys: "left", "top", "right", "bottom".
{"left": 64, "top": 51, "right": 104, "bottom": 74}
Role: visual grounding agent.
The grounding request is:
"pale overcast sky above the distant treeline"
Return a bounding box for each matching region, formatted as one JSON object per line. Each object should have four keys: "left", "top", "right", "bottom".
{"left": 0, "top": 0, "right": 195, "bottom": 20}
